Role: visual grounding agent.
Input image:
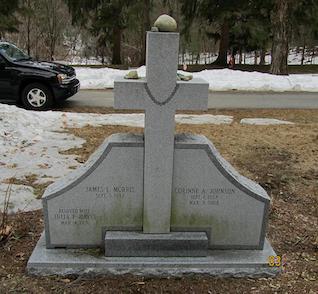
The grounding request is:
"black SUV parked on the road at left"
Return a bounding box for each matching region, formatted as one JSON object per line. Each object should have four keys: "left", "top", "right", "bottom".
{"left": 0, "top": 42, "right": 80, "bottom": 110}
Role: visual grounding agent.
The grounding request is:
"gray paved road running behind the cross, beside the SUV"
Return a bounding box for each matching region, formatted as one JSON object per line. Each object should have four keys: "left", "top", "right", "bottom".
{"left": 65, "top": 90, "right": 318, "bottom": 108}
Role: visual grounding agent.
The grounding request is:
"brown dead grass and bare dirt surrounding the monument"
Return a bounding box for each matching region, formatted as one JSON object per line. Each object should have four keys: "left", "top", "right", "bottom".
{"left": 0, "top": 110, "right": 318, "bottom": 293}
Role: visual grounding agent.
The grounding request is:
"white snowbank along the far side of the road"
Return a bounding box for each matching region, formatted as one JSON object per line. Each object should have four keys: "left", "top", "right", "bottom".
{"left": 76, "top": 66, "right": 318, "bottom": 92}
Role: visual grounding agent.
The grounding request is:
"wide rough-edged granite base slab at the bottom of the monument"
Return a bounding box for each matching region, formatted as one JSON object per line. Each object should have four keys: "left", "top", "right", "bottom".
{"left": 27, "top": 234, "right": 281, "bottom": 277}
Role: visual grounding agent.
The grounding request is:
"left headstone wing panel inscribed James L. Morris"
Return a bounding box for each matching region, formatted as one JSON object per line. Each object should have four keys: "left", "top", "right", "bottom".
{"left": 44, "top": 135, "right": 143, "bottom": 248}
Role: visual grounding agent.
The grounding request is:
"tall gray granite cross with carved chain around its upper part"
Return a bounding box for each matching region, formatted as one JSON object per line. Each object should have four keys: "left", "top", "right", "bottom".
{"left": 114, "top": 32, "right": 208, "bottom": 233}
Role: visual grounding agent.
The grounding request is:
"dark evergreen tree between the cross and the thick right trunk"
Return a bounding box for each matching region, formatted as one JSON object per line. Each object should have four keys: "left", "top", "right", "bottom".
{"left": 181, "top": 0, "right": 269, "bottom": 66}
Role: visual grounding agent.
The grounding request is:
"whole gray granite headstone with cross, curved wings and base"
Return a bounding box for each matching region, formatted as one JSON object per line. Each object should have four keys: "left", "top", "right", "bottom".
{"left": 28, "top": 14, "right": 277, "bottom": 275}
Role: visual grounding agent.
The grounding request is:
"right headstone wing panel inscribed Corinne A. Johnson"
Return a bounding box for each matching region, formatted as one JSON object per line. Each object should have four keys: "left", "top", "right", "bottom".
{"left": 171, "top": 136, "right": 269, "bottom": 249}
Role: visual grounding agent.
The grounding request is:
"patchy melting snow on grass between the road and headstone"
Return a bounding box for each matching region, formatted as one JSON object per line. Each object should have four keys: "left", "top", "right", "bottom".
{"left": 0, "top": 104, "right": 294, "bottom": 212}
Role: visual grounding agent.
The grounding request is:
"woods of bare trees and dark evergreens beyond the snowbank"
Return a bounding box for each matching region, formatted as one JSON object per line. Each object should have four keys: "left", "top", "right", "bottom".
{"left": 0, "top": 0, "right": 318, "bottom": 74}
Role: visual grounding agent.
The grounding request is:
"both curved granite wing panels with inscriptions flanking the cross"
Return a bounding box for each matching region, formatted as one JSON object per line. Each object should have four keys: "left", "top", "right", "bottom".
{"left": 43, "top": 134, "right": 270, "bottom": 249}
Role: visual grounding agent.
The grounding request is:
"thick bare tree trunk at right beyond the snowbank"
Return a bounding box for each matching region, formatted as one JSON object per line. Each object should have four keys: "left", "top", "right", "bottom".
{"left": 270, "top": 0, "right": 289, "bottom": 75}
